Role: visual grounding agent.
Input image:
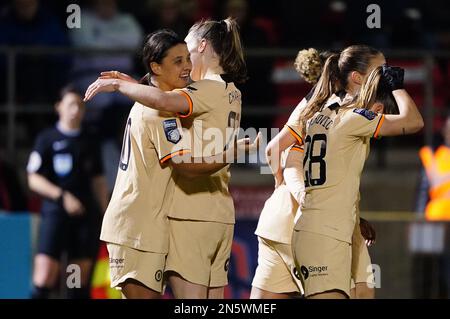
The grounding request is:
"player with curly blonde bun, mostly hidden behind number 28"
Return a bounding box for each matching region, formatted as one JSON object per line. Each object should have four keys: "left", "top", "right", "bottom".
{"left": 251, "top": 49, "right": 374, "bottom": 299}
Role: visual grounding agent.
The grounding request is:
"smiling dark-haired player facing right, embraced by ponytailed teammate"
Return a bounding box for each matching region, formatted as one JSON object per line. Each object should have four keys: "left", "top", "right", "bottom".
{"left": 100, "top": 30, "right": 191, "bottom": 299}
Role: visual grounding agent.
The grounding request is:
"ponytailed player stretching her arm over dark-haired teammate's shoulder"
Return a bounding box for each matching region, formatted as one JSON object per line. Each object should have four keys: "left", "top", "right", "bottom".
{"left": 85, "top": 19, "right": 250, "bottom": 298}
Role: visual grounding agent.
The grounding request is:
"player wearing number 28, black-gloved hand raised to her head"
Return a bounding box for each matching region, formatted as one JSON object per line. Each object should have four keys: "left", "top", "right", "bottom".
{"left": 292, "top": 62, "right": 423, "bottom": 298}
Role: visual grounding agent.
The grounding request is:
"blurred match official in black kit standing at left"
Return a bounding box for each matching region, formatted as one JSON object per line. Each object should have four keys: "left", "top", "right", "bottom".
{"left": 27, "top": 87, "right": 108, "bottom": 299}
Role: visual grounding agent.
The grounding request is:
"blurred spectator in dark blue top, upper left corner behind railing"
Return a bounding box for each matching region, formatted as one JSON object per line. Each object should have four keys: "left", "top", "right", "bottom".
{"left": 0, "top": 0, "right": 68, "bottom": 103}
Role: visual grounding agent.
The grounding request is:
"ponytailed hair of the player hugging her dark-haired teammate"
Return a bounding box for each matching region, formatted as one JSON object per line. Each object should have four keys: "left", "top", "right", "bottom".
{"left": 189, "top": 17, "right": 247, "bottom": 83}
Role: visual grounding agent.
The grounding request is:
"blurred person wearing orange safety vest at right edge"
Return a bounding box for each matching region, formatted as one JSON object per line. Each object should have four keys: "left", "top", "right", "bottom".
{"left": 414, "top": 116, "right": 450, "bottom": 298}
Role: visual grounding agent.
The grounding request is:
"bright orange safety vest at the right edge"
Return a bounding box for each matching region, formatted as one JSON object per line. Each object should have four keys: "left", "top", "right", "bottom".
{"left": 419, "top": 146, "right": 450, "bottom": 221}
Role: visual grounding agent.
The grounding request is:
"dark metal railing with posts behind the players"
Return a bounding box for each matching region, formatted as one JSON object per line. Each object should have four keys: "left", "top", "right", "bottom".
{"left": 0, "top": 46, "right": 450, "bottom": 160}
